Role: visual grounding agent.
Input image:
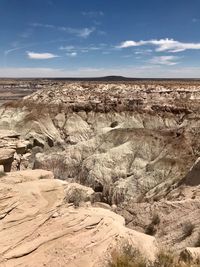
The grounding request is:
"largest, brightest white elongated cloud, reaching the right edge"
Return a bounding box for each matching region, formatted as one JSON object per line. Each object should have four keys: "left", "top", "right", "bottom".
{"left": 117, "top": 38, "right": 200, "bottom": 53}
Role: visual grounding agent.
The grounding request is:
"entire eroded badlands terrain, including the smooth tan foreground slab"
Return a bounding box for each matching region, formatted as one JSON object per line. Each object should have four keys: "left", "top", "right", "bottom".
{"left": 0, "top": 81, "right": 200, "bottom": 267}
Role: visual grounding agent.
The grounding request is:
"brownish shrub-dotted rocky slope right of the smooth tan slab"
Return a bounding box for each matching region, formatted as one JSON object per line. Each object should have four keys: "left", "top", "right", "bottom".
{"left": 117, "top": 186, "right": 200, "bottom": 252}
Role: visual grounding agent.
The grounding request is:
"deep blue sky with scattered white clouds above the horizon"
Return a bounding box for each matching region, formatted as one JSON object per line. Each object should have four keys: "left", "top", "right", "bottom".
{"left": 0, "top": 0, "right": 200, "bottom": 78}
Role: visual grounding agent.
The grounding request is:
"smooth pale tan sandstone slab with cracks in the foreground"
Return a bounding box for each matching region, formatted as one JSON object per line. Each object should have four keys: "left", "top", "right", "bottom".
{"left": 0, "top": 170, "right": 156, "bottom": 267}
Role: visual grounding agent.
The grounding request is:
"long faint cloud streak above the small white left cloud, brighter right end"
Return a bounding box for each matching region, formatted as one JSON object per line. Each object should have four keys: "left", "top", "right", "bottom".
{"left": 31, "top": 23, "right": 96, "bottom": 38}
